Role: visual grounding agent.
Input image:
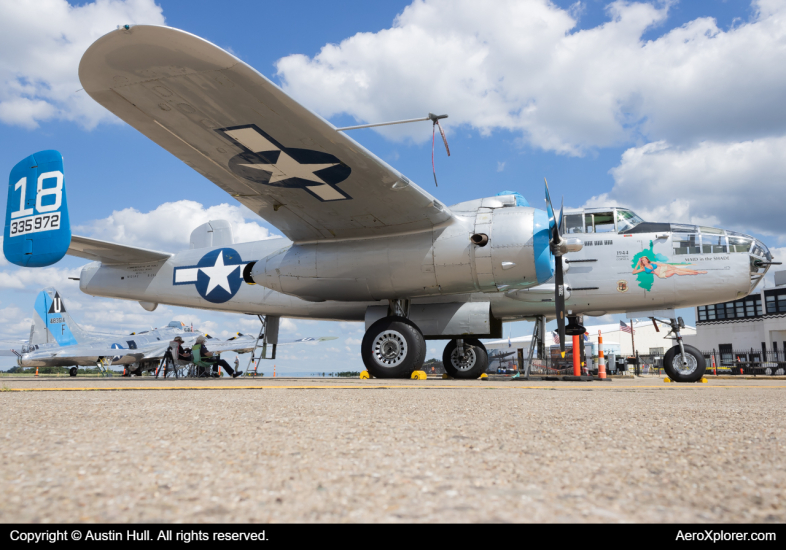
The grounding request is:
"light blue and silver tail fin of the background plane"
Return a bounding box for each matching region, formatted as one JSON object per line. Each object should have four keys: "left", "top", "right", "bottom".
{"left": 30, "top": 287, "right": 88, "bottom": 346}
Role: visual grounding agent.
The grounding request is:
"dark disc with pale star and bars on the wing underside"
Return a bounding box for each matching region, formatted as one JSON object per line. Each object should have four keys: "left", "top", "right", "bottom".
{"left": 216, "top": 124, "right": 352, "bottom": 202}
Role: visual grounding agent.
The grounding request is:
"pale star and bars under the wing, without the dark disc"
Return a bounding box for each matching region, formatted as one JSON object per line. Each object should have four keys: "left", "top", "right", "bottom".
{"left": 226, "top": 128, "right": 346, "bottom": 201}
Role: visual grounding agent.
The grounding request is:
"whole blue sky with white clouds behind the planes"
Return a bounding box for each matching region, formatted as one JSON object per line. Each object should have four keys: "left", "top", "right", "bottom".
{"left": 0, "top": 0, "right": 786, "bottom": 372}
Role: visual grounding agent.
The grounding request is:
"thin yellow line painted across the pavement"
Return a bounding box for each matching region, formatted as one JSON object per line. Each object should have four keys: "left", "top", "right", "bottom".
{"left": 2, "top": 383, "right": 786, "bottom": 392}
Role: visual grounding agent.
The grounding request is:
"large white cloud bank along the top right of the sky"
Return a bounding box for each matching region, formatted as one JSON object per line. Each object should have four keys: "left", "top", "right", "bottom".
{"left": 277, "top": 0, "right": 786, "bottom": 154}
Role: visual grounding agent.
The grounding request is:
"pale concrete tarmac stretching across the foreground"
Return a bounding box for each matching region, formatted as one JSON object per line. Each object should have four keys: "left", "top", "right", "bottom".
{"left": 0, "top": 377, "right": 786, "bottom": 523}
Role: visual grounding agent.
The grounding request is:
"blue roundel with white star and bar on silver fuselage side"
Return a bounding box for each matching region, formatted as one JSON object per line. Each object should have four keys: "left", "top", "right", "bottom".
{"left": 172, "top": 248, "right": 246, "bottom": 304}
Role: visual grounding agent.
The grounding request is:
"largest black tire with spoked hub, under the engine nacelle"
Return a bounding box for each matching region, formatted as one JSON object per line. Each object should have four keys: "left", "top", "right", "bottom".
{"left": 360, "top": 316, "right": 426, "bottom": 378}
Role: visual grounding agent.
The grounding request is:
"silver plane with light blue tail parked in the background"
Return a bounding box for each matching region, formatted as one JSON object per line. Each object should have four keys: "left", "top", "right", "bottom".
{"left": 0, "top": 288, "right": 336, "bottom": 376}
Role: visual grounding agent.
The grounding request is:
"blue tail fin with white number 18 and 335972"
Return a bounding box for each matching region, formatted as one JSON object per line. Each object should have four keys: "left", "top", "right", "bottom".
{"left": 3, "top": 151, "right": 71, "bottom": 267}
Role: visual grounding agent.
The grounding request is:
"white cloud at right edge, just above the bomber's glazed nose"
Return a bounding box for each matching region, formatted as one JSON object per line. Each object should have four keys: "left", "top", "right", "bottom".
{"left": 587, "top": 137, "right": 786, "bottom": 239}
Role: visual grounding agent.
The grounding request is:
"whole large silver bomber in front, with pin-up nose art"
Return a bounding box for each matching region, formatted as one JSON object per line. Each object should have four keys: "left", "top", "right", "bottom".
{"left": 4, "top": 25, "right": 772, "bottom": 381}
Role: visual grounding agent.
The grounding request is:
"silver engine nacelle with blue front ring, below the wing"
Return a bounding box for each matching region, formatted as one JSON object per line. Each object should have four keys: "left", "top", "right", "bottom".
{"left": 249, "top": 207, "right": 554, "bottom": 301}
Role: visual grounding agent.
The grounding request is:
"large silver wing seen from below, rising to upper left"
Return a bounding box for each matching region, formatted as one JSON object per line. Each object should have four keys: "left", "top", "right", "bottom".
{"left": 79, "top": 25, "right": 452, "bottom": 242}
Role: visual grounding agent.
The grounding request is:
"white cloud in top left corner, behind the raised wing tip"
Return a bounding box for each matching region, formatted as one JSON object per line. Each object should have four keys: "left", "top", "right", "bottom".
{"left": 0, "top": 0, "right": 164, "bottom": 128}
